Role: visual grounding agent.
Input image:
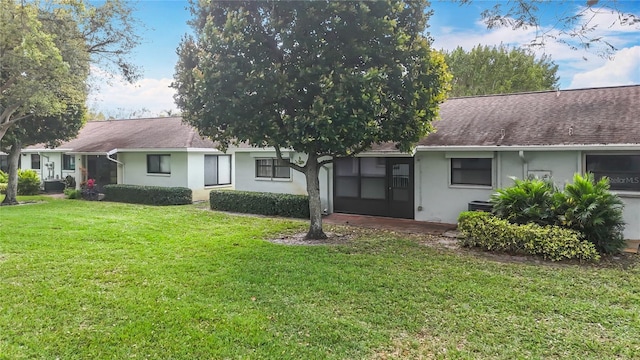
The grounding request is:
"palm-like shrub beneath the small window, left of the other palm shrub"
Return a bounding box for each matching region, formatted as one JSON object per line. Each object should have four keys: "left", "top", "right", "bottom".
{"left": 490, "top": 177, "right": 557, "bottom": 226}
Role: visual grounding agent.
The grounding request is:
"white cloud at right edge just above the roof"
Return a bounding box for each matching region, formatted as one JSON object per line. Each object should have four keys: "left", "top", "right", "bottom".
{"left": 569, "top": 46, "right": 640, "bottom": 88}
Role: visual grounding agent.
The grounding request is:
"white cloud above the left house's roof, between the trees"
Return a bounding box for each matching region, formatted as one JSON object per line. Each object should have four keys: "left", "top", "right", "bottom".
{"left": 89, "top": 67, "right": 177, "bottom": 117}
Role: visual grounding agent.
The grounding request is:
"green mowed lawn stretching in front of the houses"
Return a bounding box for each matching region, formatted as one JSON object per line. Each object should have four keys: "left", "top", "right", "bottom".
{"left": 0, "top": 200, "right": 640, "bottom": 359}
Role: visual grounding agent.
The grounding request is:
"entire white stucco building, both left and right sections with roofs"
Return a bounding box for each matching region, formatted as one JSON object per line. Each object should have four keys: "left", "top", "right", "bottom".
{"left": 16, "top": 85, "right": 640, "bottom": 239}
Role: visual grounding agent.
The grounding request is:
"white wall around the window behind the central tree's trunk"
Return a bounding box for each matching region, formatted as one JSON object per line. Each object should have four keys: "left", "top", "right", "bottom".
{"left": 233, "top": 151, "right": 333, "bottom": 212}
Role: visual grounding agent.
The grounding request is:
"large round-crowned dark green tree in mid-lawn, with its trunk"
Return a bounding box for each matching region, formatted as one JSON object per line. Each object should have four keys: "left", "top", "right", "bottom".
{"left": 172, "top": 0, "right": 450, "bottom": 239}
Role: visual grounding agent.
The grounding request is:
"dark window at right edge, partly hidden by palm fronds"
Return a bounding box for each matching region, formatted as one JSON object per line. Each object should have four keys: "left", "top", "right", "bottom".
{"left": 586, "top": 155, "right": 640, "bottom": 191}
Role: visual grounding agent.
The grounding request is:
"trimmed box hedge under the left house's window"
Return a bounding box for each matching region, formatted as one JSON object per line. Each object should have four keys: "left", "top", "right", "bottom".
{"left": 102, "top": 185, "right": 193, "bottom": 205}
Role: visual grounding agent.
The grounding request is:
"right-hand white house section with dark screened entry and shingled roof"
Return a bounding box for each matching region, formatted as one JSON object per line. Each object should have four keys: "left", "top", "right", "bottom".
{"left": 231, "top": 85, "right": 640, "bottom": 239}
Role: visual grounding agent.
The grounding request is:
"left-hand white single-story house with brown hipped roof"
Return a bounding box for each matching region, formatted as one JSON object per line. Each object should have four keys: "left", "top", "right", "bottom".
{"left": 21, "top": 117, "right": 232, "bottom": 200}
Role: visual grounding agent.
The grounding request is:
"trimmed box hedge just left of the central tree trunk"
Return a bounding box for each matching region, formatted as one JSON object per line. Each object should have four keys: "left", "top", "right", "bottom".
{"left": 209, "top": 190, "right": 309, "bottom": 219}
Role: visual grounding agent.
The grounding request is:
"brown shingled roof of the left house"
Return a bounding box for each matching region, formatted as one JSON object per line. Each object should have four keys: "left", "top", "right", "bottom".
{"left": 29, "top": 117, "right": 215, "bottom": 153}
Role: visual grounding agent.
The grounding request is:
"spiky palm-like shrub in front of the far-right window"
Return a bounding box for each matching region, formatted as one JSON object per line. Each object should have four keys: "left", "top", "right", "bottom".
{"left": 555, "top": 174, "right": 625, "bottom": 253}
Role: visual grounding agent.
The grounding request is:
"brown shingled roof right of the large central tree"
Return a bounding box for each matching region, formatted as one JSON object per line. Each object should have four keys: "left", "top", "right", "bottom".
{"left": 418, "top": 85, "right": 640, "bottom": 147}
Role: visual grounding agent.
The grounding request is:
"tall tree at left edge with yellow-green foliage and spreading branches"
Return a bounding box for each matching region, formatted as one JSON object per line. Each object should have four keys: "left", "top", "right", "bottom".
{"left": 0, "top": 0, "right": 138, "bottom": 204}
